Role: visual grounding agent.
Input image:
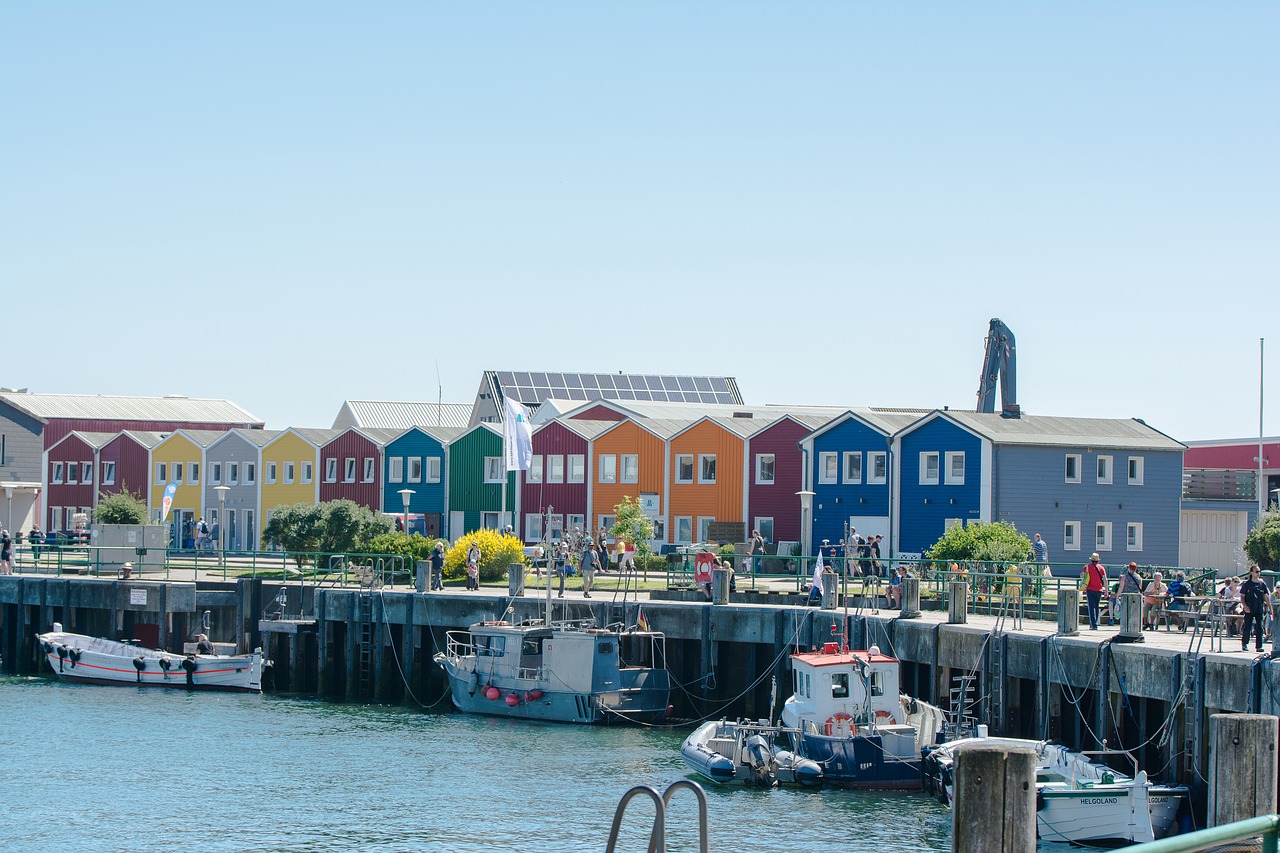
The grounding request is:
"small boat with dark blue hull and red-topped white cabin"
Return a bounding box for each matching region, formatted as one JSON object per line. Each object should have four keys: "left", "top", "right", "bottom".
{"left": 782, "top": 643, "right": 945, "bottom": 789}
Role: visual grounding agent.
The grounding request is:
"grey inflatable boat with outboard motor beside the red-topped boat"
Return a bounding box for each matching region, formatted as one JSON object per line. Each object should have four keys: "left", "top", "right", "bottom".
{"left": 680, "top": 720, "right": 822, "bottom": 788}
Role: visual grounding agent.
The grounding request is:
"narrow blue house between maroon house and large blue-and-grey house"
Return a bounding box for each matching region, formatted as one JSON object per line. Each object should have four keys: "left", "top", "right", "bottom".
{"left": 800, "top": 409, "right": 920, "bottom": 556}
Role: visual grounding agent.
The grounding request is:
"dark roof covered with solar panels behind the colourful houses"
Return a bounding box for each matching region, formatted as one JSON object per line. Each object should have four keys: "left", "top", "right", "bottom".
{"left": 485, "top": 370, "right": 742, "bottom": 407}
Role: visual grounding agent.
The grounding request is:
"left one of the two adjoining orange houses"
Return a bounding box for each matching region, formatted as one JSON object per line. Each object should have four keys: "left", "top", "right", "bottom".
{"left": 588, "top": 420, "right": 673, "bottom": 543}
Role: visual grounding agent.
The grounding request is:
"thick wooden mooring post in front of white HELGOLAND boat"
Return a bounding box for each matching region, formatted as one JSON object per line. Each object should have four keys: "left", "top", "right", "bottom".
{"left": 951, "top": 743, "right": 1036, "bottom": 853}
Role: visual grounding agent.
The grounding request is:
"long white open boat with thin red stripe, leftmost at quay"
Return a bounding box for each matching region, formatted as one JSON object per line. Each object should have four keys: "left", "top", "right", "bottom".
{"left": 36, "top": 630, "right": 270, "bottom": 693}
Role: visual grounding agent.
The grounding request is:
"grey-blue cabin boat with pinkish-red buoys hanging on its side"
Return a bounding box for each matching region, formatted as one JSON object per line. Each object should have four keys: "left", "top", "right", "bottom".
{"left": 435, "top": 620, "right": 671, "bottom": 724}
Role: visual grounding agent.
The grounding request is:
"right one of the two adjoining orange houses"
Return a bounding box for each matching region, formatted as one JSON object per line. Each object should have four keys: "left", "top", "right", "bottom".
{"left": 667, "top": 418, "right": 762, "bottom": 544}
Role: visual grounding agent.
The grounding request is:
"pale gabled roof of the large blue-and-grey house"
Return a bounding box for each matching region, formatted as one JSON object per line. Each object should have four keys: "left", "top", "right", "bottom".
{"left": 900, "top": 410, "right": 1187, "bottom": 451}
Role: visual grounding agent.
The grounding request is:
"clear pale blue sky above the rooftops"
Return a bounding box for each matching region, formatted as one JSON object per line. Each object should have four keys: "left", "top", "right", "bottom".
{"left": 0, "top": 0, "right": 1280, "bottom": 441}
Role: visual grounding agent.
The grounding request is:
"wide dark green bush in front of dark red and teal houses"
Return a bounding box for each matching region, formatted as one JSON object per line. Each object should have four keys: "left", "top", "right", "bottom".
{"left": 262, "top": 500, "right": 393, "bottom": 566}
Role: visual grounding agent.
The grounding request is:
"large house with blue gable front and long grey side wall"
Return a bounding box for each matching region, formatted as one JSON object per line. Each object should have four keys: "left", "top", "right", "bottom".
{"left": 893, "top": 411, "right": 1185, "bottom": 566}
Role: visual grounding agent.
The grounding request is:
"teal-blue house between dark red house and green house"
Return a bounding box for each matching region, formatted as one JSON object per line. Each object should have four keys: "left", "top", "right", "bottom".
{"left": 381, "top": 427, "right": 462, "bottom": 537}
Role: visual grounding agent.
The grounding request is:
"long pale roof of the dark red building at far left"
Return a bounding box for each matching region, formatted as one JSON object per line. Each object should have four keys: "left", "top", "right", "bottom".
{"left": 0, "top": 392, "right": 262, "bottom": 425}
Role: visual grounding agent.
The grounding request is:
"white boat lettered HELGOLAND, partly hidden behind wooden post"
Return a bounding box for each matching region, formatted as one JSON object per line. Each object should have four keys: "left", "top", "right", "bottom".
{"left": 924, "top": 738, "right": 1188, "bottom": 845}
